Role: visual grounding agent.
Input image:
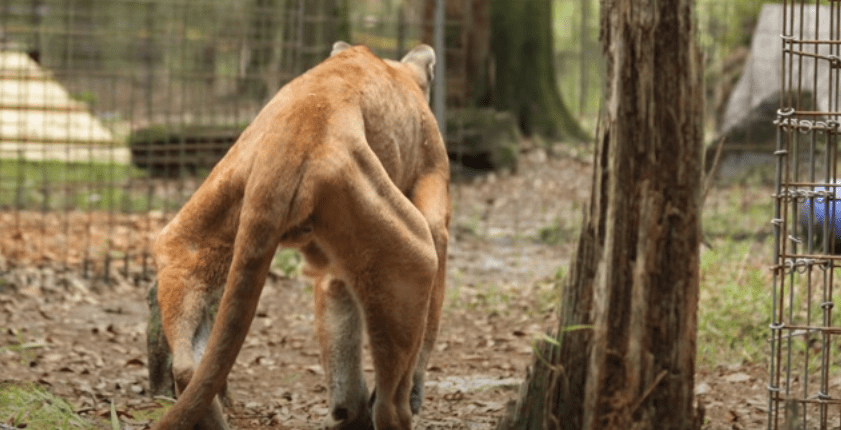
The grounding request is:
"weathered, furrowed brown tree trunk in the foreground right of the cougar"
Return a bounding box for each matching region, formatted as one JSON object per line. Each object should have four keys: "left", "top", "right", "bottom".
{"left": 500, "top": 0, "right": 703, "bottom": 429}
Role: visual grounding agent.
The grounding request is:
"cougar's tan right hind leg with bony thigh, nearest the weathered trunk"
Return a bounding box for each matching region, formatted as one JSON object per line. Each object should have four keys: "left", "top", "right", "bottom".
{"left": 314, "top": 136, "right": 438, "bottom": 430}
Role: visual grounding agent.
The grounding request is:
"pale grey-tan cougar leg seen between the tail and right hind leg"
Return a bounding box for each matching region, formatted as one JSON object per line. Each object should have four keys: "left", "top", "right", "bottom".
{"left": 314, "top": 274, "right": 373, "bottom": 430}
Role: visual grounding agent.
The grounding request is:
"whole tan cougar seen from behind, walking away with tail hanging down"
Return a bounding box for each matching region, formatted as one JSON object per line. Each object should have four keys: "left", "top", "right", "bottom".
{"left": 154, "top": 42, "right": 450, "bottom": 430}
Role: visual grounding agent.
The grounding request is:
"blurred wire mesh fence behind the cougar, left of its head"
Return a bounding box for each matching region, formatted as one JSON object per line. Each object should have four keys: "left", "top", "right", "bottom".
{"left": 0, "top": 0, "right": 422, "bottom": 279}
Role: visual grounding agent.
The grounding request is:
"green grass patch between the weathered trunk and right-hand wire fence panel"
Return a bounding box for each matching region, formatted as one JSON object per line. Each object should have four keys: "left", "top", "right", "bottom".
{"left": 698, "top": 186, "right": 773, "bottom": 367}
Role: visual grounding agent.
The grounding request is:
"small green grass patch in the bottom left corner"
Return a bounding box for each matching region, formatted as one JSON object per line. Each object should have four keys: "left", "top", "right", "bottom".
{"left": 0, "top": 382, "right": 97, "bottom": 430}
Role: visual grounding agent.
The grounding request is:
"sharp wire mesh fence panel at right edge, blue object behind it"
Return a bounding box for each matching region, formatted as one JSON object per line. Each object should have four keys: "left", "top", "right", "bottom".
{"left": 763, "top": 0, "right": 841, "bottom": 429}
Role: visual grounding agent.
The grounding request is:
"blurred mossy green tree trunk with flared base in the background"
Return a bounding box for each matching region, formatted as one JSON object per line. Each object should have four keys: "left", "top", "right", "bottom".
{"left": 491, "top": 0, "right": 587, "bottom": 140}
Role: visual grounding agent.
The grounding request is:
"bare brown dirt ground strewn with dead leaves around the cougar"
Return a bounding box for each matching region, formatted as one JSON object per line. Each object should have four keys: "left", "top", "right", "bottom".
{"left": 0, "top": 148, "right": 768, "bottom": 430}
